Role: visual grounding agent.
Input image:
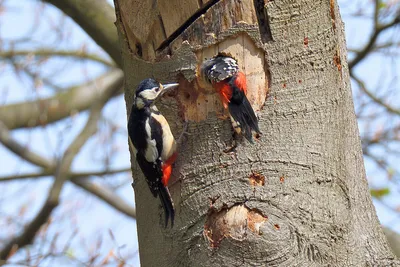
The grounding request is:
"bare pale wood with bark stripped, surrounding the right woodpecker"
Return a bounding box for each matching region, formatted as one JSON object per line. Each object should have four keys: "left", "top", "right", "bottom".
{"left": 173, "top": 33, "right": 268, "bottom": 122}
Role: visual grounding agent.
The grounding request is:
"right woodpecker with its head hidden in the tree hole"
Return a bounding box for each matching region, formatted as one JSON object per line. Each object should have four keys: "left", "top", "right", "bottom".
{"left": 200, "top": 54, "right": 261, "bottom": 143}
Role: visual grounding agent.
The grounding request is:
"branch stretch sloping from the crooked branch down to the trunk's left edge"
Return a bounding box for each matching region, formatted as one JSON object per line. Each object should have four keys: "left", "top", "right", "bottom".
{"left": 71, "top": 178, "right": 136, "bottom": 219}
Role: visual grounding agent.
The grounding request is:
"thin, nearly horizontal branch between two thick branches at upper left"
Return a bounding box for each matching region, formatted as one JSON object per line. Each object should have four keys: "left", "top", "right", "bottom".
{"left": 0, "top": 49, "right": 115, "bottom": 67}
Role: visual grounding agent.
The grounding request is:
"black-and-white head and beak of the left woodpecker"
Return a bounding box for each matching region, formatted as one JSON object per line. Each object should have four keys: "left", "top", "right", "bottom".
{"left": 133, "top": 78, "right": 179, "bottom": 109}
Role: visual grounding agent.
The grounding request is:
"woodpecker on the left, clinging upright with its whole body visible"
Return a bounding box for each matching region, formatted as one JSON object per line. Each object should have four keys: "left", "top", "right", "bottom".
{"left": 128, "top": 79, "right": 178, "bottom": 227}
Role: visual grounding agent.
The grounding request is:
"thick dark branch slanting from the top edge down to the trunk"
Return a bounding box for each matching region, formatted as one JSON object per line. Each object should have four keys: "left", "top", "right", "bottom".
{"left": 42, "top": 0, "right": 122, "bottom": 67}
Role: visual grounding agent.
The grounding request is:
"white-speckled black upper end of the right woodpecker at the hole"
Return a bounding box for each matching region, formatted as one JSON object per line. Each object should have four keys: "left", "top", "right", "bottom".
{"left": 200, "top": 56, "right": 239, "bottom": 83}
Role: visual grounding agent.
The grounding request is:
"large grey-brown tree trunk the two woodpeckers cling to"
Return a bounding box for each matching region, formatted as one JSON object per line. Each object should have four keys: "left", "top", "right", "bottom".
{"left": 115, "top": 0, "right": 398, "bottom": 266}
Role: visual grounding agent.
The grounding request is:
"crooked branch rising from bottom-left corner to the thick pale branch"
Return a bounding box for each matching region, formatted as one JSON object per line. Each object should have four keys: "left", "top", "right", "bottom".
{"left": 0, "top": 102, "right": 101, "bottom": 261}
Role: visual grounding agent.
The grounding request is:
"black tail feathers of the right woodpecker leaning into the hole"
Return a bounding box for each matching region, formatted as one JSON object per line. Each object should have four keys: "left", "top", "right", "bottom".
{"left": 228, "top": 96, "right": 261, "bottom": 143}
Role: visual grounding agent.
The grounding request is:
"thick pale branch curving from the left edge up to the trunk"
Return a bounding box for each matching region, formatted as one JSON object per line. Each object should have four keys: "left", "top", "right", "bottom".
{"left": 0, "top": 69, "right": 123, "bottom": 129}
